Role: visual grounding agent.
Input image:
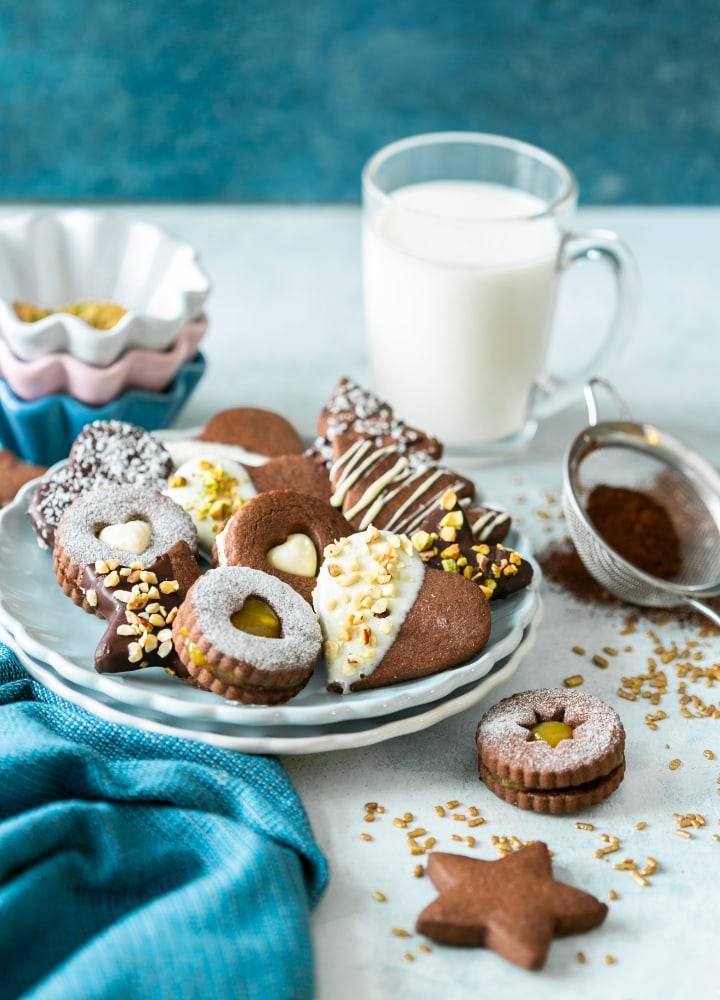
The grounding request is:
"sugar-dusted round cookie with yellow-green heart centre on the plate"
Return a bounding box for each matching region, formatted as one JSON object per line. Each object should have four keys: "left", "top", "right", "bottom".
{"left": 173, "top": 566, "right": 322, "bottom": 705}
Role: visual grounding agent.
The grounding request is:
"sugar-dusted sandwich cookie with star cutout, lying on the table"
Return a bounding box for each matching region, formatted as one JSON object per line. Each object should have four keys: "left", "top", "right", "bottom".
{"left": 476, "top": 688, "right": 625, "bottom": 815}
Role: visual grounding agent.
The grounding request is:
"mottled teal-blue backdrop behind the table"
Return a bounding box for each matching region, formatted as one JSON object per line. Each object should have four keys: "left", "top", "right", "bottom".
{"left": 0, "top": 0, "right": 720, "bottom": 204}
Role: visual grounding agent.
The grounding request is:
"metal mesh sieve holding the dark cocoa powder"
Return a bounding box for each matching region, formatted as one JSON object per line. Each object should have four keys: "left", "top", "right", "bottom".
{"left": 563, "top": 378, "right": 720, "bottom": 625}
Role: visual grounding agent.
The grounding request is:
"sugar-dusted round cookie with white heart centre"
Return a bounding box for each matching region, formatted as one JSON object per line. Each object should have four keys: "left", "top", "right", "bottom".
{"left": 53, "top": 485, "right": 198, "bottom": 617}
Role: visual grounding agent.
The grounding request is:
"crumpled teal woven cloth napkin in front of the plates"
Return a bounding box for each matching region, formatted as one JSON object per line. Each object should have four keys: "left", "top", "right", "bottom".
{"left": 0, "top": 645, "right": 328, "bottom": 1000}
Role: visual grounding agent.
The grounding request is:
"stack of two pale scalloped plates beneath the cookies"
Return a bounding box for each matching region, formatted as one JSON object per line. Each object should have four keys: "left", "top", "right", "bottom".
{"left": 0, "top": 483, "right": 541, "bottom": 754}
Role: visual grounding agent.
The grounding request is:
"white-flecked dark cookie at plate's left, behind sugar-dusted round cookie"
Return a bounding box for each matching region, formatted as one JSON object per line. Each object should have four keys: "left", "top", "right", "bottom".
{"left": 28, "top": 420, "right": 173, "bottom": 548}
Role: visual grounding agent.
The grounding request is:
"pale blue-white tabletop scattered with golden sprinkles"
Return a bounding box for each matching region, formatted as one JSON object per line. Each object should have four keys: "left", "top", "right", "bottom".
{"left": 0, "top": 205, "right": 720, "bottom": 1000}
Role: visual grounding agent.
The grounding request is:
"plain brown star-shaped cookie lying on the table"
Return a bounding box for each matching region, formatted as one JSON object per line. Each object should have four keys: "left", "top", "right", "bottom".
{"left": 416, "top": 841, "right": 608, "bottom": 969}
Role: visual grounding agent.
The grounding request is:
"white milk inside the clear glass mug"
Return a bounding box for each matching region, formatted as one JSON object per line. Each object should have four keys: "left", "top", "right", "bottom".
{"left": 363, "top": 181, "right": 561, "bottom": 448}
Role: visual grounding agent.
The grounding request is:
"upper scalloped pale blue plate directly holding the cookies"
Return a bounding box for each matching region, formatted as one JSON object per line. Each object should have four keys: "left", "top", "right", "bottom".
{"left": 0, "top": 483, "right": 540, "bottom": 726}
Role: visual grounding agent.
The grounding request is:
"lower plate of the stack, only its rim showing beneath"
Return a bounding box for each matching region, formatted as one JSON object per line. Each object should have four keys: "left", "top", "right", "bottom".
{"left": 0, "top": 602, "right": 542, "bottom": 754}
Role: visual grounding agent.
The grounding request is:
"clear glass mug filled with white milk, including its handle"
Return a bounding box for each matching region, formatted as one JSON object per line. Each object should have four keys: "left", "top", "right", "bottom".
{"left": 362, "top": 132, "right": 637, "bottom": 456}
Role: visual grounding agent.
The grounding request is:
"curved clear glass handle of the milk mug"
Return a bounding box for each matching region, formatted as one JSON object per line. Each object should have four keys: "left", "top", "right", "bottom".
{"left": 531, "top": 229, "right": 640, "bottom": 420}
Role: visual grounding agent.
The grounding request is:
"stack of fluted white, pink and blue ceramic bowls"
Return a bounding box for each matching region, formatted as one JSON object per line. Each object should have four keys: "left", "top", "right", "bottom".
{"left": 0, "top": 209, "right": 210, "bottom": 465}
